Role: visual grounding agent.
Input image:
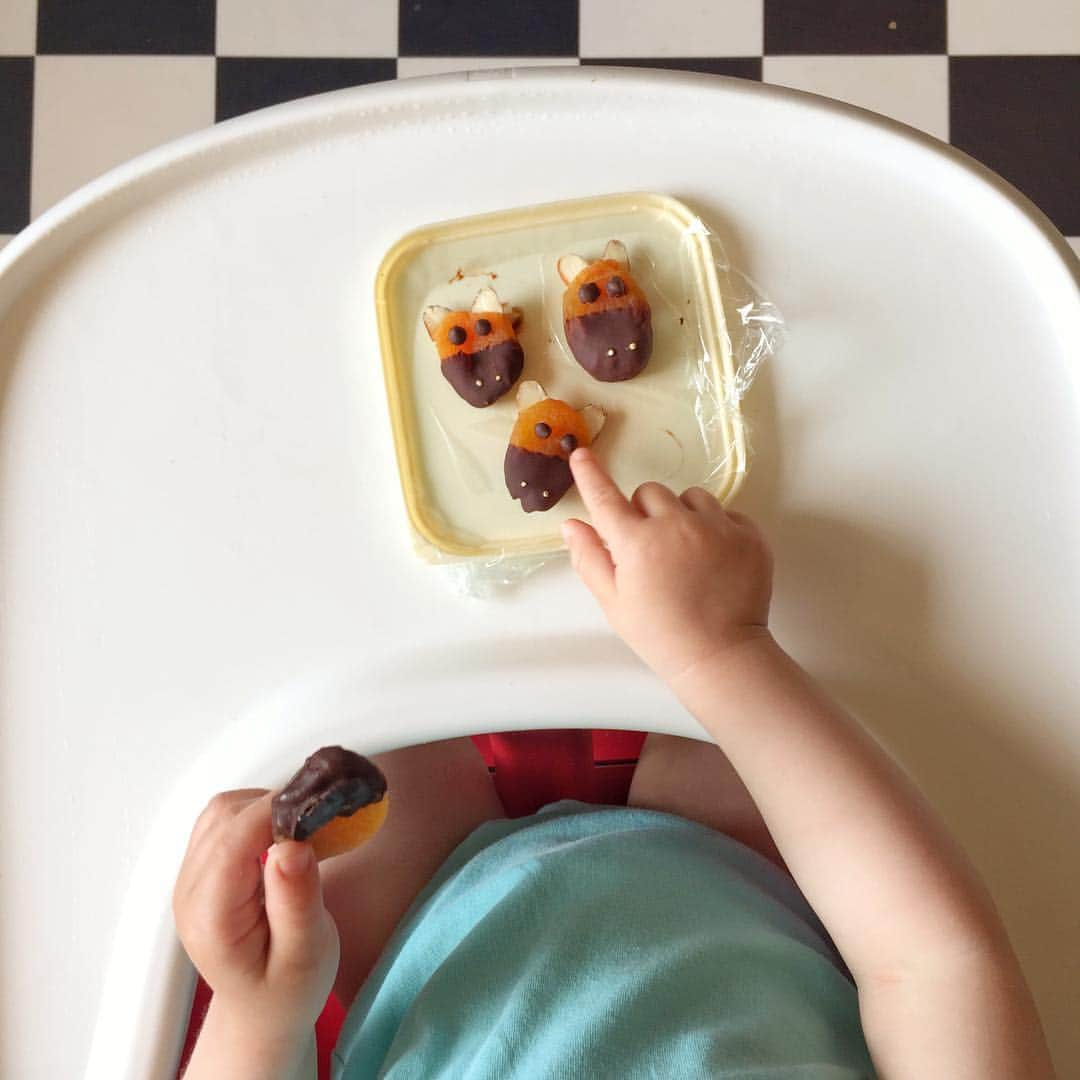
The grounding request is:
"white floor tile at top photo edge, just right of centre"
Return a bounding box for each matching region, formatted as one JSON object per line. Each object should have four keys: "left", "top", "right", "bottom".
{"left": 579, "top": 0, "right": 765, "bottom": 58}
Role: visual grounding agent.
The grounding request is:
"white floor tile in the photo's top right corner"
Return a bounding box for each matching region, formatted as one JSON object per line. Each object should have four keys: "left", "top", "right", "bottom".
{"left": 948, "top": 0, "right": 1080, "bottom": 55}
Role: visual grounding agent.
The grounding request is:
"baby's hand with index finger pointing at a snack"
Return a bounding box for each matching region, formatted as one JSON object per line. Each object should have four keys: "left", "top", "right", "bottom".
{"left": 563, "top": 449, "right": 772, "bottom": 684}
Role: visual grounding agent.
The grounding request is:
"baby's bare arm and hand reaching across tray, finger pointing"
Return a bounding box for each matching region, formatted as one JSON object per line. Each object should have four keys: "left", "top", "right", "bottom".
{"left": 566, "top": 450, "right": 1053, "bottom": 1080}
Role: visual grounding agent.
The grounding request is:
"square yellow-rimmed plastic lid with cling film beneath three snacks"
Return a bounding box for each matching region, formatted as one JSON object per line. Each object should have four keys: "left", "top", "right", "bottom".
{"left": 376, "top": 193, "right": 784, "bottom": 596}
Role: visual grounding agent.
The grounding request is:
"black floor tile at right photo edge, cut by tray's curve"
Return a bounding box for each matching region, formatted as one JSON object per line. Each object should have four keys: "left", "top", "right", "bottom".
{"left": 949, "top": 56, "right": 1080, "bottom": 235}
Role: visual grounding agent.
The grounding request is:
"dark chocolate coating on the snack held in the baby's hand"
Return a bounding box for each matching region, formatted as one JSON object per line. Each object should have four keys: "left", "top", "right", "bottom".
{"left": 270, "top": 746, "right": 387, "bottom": 841}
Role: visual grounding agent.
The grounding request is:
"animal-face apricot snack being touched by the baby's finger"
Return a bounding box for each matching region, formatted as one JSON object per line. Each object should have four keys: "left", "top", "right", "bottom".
{"left": 502, "top": 380, "right": 606, "bottom": 513}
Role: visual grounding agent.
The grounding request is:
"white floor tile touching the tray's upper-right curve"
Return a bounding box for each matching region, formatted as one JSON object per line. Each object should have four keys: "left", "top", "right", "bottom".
{"left": 762, "top": 56, "right": 948, "bottom": 139}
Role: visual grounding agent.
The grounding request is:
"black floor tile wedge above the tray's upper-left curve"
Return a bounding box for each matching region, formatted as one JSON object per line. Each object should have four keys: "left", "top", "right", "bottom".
{"left": 215, "top": 56, "right": 397, "bottom": 120}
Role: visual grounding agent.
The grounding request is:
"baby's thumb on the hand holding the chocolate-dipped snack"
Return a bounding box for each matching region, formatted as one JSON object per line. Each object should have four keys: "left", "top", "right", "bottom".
{"left": 262, "top": 840, "right": 330, "bottom": 969}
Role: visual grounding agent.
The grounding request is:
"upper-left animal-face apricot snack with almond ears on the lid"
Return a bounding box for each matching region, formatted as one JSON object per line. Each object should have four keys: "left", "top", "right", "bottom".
{"left": 423, "top": 288, "right": 525, "bottom": 408}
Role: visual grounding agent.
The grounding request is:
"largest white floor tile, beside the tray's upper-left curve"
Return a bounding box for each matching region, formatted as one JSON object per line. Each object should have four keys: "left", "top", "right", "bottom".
{"left": 30, "top": 56, "right": 214, "bottom": 217}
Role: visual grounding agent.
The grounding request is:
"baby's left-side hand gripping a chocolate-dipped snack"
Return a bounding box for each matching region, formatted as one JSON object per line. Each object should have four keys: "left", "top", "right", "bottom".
{"left": 173, "top": 789, "right": 338, "bottom": 1036}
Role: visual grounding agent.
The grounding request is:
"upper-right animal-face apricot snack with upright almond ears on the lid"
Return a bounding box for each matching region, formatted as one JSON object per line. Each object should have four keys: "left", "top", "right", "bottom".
{"left": 557, "top": 240, "right": 652, "bottom": 382}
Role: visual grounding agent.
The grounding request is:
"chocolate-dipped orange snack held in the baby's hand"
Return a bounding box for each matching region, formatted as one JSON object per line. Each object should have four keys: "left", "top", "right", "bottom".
{"left": 270, "top": 746, "right": 390, "bottom": 860}
